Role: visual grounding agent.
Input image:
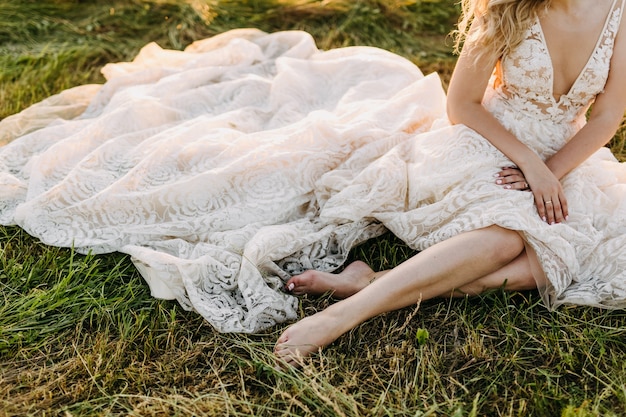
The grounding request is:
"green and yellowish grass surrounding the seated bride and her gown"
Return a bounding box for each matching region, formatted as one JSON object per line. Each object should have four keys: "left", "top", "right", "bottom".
{"left": 0, "top": 0, "right": 626, "bottom": 417}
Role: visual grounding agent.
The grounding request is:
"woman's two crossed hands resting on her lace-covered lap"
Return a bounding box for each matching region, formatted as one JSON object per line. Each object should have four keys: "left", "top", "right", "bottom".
{"left": 496, "top": 165, "right": 569, "bottom": 224}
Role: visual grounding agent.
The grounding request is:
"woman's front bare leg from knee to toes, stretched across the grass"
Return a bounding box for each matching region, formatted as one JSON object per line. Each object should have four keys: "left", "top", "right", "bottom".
{"left": 274, "top": 226, "right": 524, "bottom": 365}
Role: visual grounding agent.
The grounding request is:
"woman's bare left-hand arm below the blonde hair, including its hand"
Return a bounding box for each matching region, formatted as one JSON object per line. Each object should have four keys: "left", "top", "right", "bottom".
{"left": 447, "top": 37, "right": 568, "bottom": 224}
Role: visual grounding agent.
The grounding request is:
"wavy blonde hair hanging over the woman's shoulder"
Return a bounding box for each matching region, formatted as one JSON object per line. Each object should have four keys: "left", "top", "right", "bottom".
{"left": 453, "top": 0, "right": 551, "bottom": 60}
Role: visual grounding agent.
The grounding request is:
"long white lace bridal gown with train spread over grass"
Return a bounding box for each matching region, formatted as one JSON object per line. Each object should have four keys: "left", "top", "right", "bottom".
{"left": 0, "top": 0, "right": 626, "bottom": 332}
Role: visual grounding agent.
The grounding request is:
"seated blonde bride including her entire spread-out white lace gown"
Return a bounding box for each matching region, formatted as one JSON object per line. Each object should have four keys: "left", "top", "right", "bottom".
{"left": 0, "top": 0, "right": 626, "bottom": 346}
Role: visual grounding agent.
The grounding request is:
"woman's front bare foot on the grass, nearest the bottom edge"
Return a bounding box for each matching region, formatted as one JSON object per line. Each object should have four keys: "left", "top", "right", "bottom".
{"left": 274, "top": 311, "right": 343, "bottom": 368}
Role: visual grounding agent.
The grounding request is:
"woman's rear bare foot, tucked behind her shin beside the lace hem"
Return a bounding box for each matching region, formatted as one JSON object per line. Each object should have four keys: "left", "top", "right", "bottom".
{"left": 285, "top": 261, "right": 375, "bottom": 298}
